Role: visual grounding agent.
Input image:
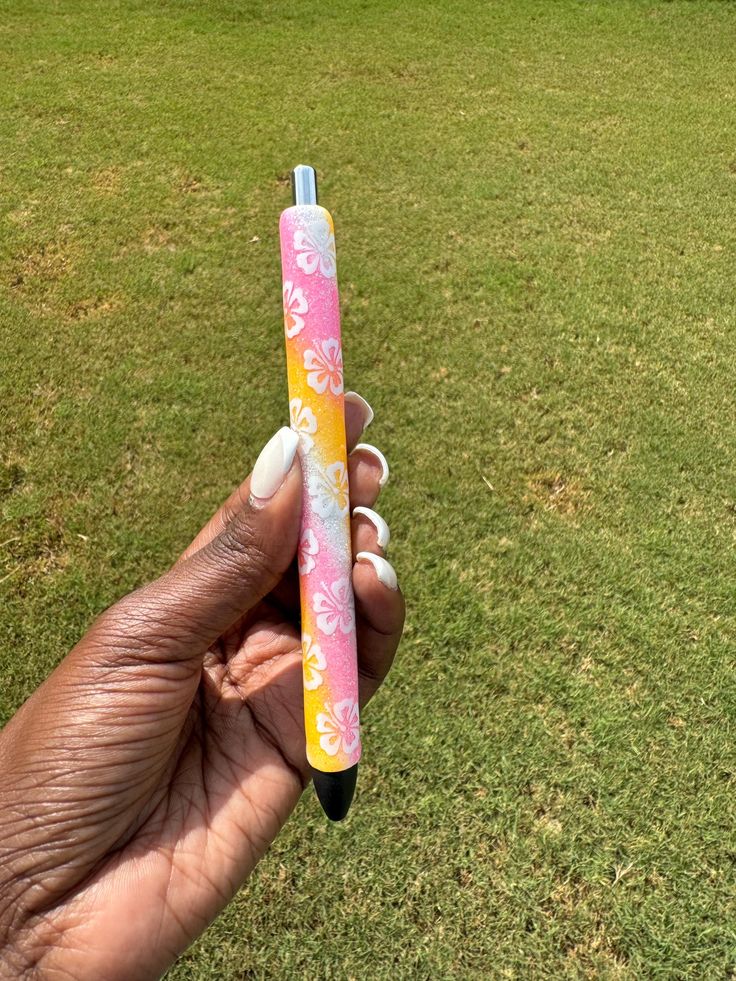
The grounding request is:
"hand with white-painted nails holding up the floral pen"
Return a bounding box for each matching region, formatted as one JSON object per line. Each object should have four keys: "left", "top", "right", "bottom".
{"left": 0, "top": 399, "right": 404, "bottom": 981}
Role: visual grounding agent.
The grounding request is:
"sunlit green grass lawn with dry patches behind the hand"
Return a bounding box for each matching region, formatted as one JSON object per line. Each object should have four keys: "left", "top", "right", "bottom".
{"left": 0, "top": 0, "right": 736, "bottom": 981}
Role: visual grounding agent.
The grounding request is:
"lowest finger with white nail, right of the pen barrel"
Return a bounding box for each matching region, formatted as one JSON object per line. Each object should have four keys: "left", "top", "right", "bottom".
{"left": 353, "top": 552, "right": 405, "bottom": 705}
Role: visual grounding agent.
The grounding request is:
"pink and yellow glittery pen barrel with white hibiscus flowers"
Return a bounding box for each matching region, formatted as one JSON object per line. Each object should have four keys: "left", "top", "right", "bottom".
{"left": 279, "top": 204, "right": 360, "bottom": 773}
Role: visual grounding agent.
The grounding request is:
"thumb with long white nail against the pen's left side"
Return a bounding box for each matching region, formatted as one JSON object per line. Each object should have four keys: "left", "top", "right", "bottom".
{"left": 103, "top": 427, "right": 301, "bottom": 662}
